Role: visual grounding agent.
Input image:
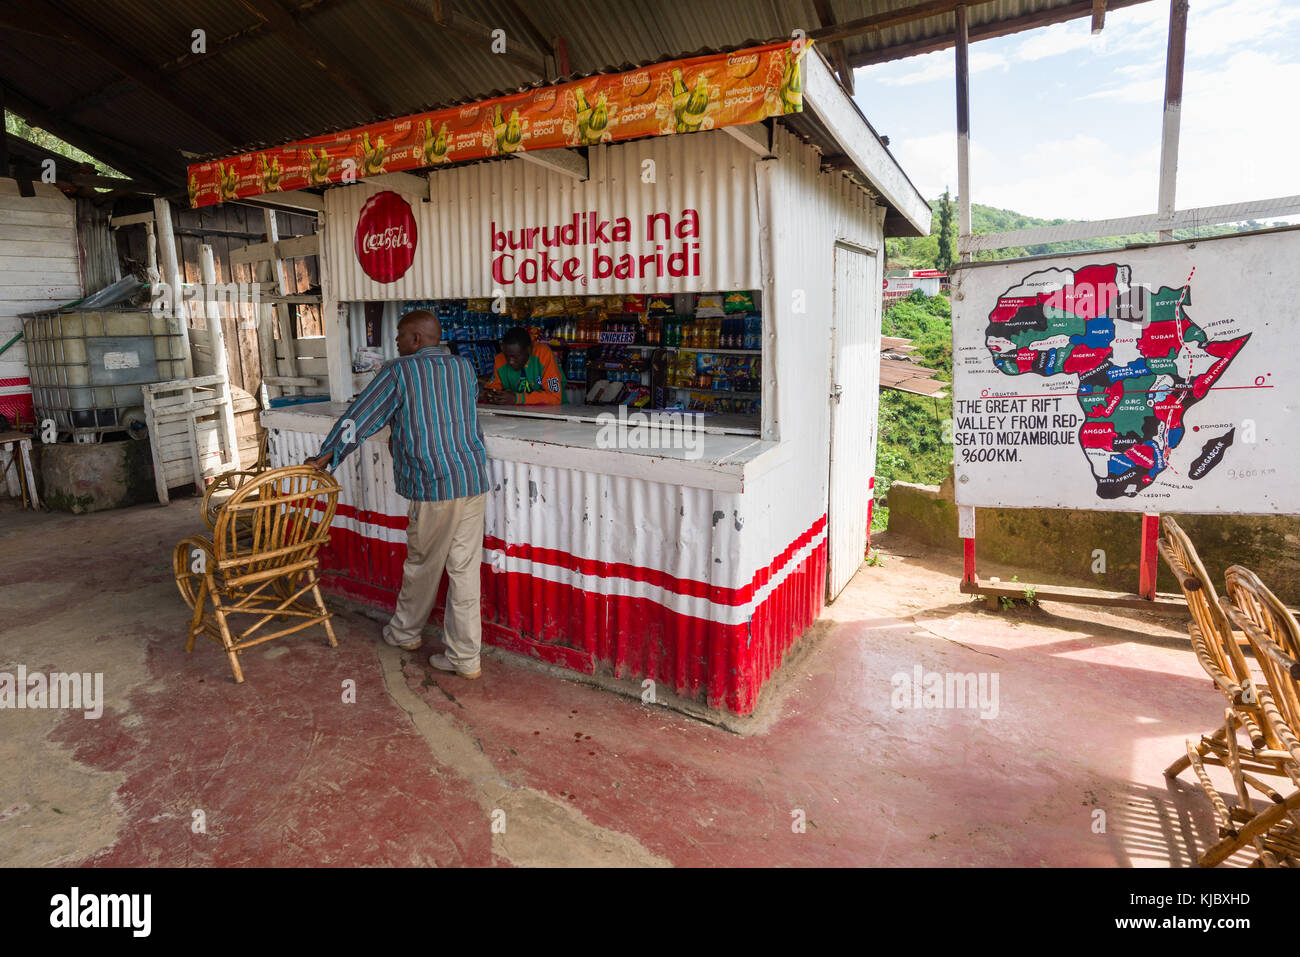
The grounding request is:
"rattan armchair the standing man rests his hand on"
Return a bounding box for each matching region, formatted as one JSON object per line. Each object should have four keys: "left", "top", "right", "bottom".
{"left": 173, "top": 465, "right": 339, "bottom": 683}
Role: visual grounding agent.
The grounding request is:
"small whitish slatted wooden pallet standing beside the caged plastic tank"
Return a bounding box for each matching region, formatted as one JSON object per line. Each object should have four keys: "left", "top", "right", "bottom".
{"left": 140, "top": 376, "right": 239, "bottom": 505}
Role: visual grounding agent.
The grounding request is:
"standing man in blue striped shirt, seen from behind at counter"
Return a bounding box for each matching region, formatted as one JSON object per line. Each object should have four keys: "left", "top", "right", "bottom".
{"left": 307, "top": 309, "right": 488, "bottom": 677}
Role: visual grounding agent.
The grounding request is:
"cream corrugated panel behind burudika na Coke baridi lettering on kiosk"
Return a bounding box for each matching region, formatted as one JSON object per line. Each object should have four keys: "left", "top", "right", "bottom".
{"left": 325, "top": 131, "right": 759, "bottom": 302}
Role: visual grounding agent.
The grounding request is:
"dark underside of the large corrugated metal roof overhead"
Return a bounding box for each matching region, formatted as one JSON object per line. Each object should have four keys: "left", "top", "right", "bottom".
{"left": 0, "top": 0, "right": 1139, "bottom": 191}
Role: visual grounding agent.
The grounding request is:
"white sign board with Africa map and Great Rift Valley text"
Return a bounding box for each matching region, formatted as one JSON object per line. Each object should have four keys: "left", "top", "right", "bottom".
{"left": 953, "top": 229, "right": 1300, "bottom": 514}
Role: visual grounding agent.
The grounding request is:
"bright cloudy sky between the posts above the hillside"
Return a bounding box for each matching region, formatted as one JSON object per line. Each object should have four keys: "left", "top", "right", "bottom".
{"left": 854, "top": 0, "right": 1300, "bottom": 220}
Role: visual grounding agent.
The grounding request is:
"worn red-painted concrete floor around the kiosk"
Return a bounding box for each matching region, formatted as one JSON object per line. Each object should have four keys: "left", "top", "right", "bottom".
{"left": 0, "top": 499, "right": 1242, "bottom": 867}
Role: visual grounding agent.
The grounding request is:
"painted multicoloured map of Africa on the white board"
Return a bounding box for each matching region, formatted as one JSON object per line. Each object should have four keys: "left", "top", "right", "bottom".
{"left": 984, "top": 263, "right": 1251, "bottom": 499}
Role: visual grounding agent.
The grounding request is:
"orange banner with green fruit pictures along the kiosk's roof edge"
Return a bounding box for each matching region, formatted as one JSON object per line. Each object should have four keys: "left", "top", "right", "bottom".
{"left": 189, "top": 39, "right": 809, "bottom": 207}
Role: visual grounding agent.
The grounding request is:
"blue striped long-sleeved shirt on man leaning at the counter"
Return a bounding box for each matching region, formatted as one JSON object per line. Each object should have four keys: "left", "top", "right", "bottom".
{"left": 317, "top": 346, "right": 488, "bottom": 502}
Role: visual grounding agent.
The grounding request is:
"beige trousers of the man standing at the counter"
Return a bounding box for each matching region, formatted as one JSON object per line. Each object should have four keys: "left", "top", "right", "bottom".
{"left": 386, "top": 493, "right": 488, "bottom": 672}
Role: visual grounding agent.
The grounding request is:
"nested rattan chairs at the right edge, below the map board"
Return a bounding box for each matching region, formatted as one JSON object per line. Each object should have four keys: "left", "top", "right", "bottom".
{"left": 1160, "top": 516, "right": 1300, "bottom": 867}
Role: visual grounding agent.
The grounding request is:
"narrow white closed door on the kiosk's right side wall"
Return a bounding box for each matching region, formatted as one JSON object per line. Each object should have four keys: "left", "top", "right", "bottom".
{"left": 827, "top": 244, "right": 880, "bottom": 601}
